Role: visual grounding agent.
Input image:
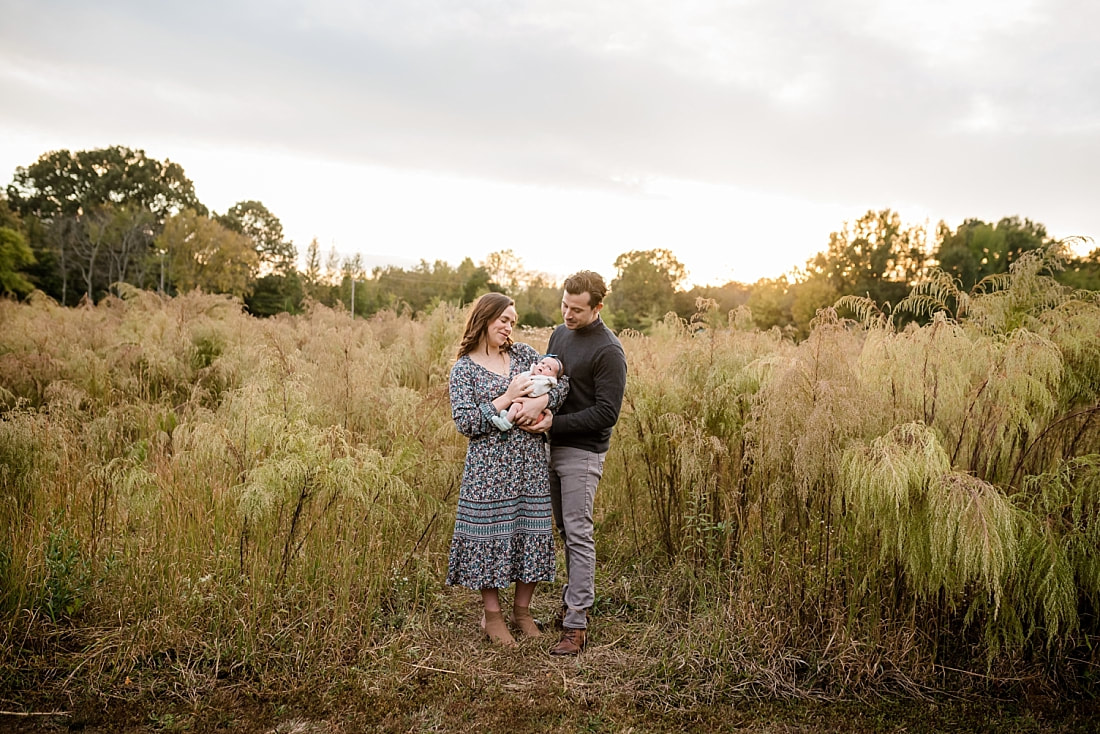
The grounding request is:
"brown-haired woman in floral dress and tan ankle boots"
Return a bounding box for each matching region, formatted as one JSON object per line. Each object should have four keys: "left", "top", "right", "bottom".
{"left": 447, "top": 293, "right": 569, "bottom": 646}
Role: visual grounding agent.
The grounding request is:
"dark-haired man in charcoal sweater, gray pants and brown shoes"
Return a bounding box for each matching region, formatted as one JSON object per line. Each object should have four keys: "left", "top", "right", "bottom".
{"left": 538, "top": 271, "right": 626, "bottom": 655}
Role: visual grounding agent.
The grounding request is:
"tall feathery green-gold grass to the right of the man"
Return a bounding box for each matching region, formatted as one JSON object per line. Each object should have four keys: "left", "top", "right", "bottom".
{"left": 604, "top": 249, "right": 1100, "bottom": 682}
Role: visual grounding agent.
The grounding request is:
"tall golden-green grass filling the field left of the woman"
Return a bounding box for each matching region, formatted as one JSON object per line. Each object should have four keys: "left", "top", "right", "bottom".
{"left": 0, "top": 293, "right": 464, "bottom": 691}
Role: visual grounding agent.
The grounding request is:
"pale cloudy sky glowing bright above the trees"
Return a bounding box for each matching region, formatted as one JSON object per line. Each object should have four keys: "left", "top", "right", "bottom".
{"left": 0, "top": 0, "right": 1100, "bottom": 284}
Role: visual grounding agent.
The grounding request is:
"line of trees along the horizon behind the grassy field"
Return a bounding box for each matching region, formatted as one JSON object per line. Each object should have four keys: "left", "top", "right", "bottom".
{"left": 0, "top": 146, "right": 1100, "bottom": 337}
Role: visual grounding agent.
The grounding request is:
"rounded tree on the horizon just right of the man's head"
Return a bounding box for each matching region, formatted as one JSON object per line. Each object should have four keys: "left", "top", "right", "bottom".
{"left": 607, "top": 249, "right": 688, "bottom": 330}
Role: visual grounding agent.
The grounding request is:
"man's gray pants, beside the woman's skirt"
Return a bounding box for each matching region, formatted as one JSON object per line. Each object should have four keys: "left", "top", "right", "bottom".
{"left": 550, "top": 443, "right": 607, "bottom": 629}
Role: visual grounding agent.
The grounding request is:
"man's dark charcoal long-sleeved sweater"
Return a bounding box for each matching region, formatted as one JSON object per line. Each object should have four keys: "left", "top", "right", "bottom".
{"left": 548, "top": 318, "right": 626, "bottom": 453}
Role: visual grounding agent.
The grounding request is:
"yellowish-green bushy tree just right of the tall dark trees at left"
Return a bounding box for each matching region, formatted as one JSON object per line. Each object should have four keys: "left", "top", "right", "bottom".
{"left": 157, "top": 209, "right": 260, "bottom": 298}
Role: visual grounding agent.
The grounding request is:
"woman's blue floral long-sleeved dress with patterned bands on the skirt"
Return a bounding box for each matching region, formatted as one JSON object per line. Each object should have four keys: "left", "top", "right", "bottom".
{"left": 447, "top": 343, "right": 569, "bottom": 589}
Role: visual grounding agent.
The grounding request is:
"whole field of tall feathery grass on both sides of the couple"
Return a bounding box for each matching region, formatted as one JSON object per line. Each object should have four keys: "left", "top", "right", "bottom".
{"left": 0, "top": 248, "right": 1100, "bottom": 700}
